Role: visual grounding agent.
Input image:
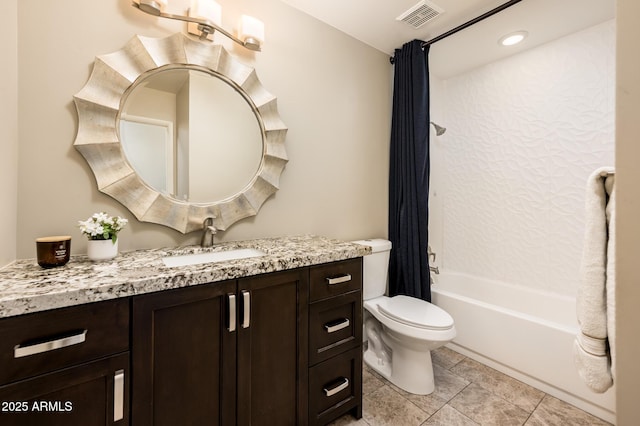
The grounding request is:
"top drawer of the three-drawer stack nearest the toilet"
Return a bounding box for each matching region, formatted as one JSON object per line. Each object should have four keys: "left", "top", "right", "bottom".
{"left": 309, "top": 258, "right": 362, "bottom": 302}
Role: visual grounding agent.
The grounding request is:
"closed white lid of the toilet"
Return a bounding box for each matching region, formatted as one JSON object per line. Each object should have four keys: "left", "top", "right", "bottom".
{"left": 378, "top": 296, "right": 453, "bottom": 330}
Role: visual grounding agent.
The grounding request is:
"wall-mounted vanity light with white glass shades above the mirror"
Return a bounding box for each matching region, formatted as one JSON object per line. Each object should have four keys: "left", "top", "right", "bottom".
{"left": 132, "top": 0, "right": 264, "bottom": 52}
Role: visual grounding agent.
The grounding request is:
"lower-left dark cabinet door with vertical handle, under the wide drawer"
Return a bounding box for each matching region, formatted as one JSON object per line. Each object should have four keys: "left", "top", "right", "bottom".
{"left": 0, "top": 352, "right": 129, "bottom": 426}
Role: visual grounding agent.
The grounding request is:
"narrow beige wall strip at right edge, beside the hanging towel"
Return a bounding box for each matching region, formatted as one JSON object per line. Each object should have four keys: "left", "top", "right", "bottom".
{"left": 615, "top": 0, "right": 640, "bottom": 426}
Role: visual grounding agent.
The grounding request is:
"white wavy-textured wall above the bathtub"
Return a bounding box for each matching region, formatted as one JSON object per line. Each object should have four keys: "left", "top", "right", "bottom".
{"left": 430, "top": 21, "right": 615, "bottom": 296}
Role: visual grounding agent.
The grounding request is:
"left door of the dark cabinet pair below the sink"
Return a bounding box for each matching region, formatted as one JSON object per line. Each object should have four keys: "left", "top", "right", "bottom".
{"left": 132, "top": 281, "right": 236, "bottom": 426}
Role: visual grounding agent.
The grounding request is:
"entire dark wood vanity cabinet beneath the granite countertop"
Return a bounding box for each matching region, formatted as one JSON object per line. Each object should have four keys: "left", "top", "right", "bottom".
{"left": 0, "top": 258, "right": 362, "bottom": 426}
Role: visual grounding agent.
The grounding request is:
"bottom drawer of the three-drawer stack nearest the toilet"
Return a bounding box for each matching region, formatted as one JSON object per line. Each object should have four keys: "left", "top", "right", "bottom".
{"left": 309, "top": 348, "right": 362, "bottom": 425}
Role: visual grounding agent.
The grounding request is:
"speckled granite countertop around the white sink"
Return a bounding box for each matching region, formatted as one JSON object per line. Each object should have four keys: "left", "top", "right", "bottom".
{"left": 0, "top": 235, "right": 371, "bottom": 318}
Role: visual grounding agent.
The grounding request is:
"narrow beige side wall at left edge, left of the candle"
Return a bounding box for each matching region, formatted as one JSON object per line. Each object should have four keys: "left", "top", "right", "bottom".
{"left": 0, "top": 0, "right": 17, "bottom": 267}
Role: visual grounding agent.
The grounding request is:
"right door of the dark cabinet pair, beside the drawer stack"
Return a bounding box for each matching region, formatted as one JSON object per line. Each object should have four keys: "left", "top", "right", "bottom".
{"left": 237, "top": 269, "right": 309, "bottom": 426}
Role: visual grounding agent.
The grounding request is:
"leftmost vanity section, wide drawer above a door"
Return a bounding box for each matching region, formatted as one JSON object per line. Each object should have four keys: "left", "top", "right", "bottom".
{"left": 0, "top": 299, "right": 130, "bottom": 426}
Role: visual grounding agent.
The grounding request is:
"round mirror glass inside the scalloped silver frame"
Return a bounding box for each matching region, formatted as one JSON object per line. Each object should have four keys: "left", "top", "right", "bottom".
{"left": 118, "top": 67, "right": 263, "bottom": 204}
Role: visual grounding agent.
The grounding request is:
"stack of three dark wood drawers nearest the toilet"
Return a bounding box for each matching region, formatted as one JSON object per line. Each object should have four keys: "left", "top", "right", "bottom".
{"left": 308, "top": 258, "right": 362, "bottom": 425}
